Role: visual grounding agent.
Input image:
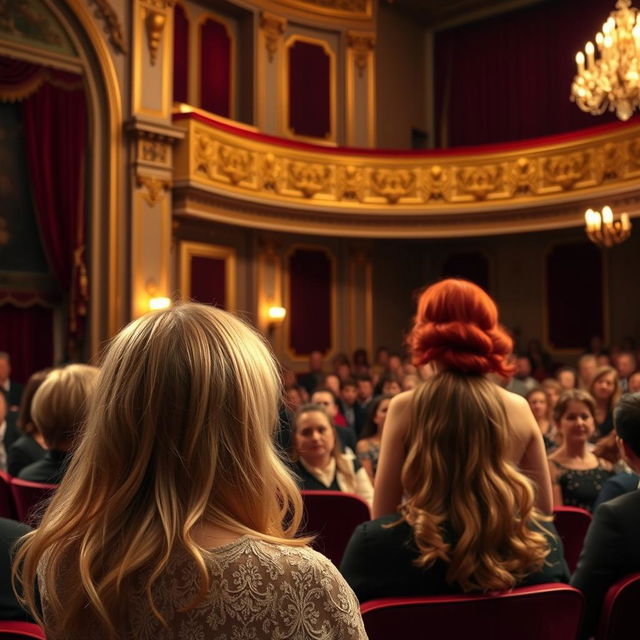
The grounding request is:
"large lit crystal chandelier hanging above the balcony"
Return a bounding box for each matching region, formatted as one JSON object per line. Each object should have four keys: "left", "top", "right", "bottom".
{"left": 571, "top": 0, "right": 640, "bottom": 120}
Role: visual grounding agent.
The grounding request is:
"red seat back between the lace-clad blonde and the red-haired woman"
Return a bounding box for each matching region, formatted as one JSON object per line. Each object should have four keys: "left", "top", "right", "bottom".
{"left": 301, "top": 491, "right": 371, "bottom": 567}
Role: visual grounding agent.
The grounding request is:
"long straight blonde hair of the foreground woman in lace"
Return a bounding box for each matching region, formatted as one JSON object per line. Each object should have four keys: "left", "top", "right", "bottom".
{"left": 16, "top": 304, "right": 306, "bottom": 638}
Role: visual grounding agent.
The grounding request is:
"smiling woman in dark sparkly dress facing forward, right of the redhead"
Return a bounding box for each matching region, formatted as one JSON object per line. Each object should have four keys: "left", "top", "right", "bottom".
{"left": 549, "top": 389, "right": 612, "bottom": 511}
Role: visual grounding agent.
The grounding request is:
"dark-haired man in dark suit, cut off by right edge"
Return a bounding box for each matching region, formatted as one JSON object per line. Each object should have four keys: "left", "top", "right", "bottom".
{"left": 571, "top": 393, "right": 640, "bottom": 638}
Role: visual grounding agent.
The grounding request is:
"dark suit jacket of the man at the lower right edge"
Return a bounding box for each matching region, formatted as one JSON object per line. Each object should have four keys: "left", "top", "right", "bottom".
{"left": 571, "top": 490, "right": 640, "bottom": 638}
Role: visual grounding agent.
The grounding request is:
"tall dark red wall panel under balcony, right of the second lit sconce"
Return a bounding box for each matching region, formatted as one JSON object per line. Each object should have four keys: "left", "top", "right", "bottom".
{"left": 289, "top": 249, "right": 333, "bottom": 355}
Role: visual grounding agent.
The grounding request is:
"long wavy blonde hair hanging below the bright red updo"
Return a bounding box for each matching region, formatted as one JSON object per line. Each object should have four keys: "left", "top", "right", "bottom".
{"left": 400, "top": 371, "right": 549, "bottom": 591}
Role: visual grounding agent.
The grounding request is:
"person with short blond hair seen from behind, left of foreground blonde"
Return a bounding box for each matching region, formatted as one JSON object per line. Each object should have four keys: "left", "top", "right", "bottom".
{"left": 18, "top": 364, "right": 98, "bottom": 484}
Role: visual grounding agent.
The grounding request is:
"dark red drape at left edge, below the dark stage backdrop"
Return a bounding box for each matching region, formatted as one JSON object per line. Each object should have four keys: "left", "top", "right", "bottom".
{"left": 0, "top": 305, "right": 53, "bottom": 382}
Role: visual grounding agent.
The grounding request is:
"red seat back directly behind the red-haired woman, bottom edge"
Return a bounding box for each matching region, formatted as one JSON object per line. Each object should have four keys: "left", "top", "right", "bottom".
{"left": 360, "top": 583, "right": 583, "bottom": 640}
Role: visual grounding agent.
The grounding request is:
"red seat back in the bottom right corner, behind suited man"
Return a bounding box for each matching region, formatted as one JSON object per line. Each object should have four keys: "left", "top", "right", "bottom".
{"left": 596, "top": 573, "right": 640, "bottom": 640}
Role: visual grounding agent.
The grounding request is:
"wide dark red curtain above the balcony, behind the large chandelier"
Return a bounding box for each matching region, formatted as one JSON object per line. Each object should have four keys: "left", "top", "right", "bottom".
{"left": 434, "top": 0, "right": 632, "bottom": 147}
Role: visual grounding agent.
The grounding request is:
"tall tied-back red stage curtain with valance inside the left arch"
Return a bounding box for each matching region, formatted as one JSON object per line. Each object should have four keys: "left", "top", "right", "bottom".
{"left": 0, "top": 57, "right": 89, "bottom": 351}
